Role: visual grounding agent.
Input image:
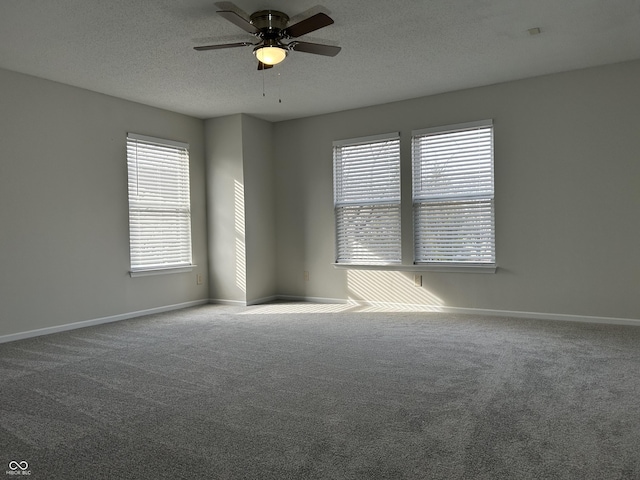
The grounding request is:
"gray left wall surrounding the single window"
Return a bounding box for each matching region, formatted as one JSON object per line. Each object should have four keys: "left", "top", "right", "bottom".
{"left": 0, "top": 70, "right": 208, "bottom": 335}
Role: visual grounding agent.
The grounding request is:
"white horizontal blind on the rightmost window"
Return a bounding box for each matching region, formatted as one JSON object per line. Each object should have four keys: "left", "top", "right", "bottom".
{"left": 412, "top": 120, "right": 495, "bottom": 265}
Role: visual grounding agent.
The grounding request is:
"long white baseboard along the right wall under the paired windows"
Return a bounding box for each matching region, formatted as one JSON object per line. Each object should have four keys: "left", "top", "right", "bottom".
{"left": 270, "top": 295, "right": 640, "bottom": 327}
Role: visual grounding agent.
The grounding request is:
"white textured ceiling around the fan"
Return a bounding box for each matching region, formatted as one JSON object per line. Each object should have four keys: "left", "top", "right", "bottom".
{"left": 0, "top": 0, "right": 640, "bottom": 120}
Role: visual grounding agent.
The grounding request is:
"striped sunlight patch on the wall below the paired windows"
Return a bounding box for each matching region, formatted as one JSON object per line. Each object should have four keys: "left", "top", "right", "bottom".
{"left": 347, "top": 270, "right": 444, "bottom": 312}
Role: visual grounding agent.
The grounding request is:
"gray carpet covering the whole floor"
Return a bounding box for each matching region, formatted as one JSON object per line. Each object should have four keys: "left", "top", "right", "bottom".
{"left": 0, "top": 305, "right": 640, "bottom": 480}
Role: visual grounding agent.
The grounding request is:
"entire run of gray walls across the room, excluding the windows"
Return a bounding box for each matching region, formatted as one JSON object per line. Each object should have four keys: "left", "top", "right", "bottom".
{"left": 0, "top": 61, "right": 640, "bottom": 336}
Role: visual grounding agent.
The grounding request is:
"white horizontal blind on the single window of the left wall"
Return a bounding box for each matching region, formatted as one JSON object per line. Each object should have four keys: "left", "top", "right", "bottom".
{"left": 127, "top": 133, "right": 192, "bottom": 271}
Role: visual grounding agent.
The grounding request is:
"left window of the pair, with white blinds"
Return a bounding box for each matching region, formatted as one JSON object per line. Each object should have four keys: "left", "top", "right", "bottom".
{"left": 333, "top": 133, "right": 401, "bottom": 265}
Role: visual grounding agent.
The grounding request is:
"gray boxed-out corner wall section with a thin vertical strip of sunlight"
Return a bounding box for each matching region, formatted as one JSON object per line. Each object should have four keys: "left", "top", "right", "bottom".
{"left": 205, "top": 114, "right": 276, "bottom": 304}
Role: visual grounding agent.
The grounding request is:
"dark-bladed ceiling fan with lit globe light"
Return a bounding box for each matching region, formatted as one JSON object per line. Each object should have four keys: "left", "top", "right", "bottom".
{"left": 193, "top": 4, "right": 341, "bottom": 70}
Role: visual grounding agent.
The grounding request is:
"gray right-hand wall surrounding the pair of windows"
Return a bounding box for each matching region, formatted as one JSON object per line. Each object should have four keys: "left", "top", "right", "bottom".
{"left": 274, "top": 61, "right": 640, "bottom": 319}
